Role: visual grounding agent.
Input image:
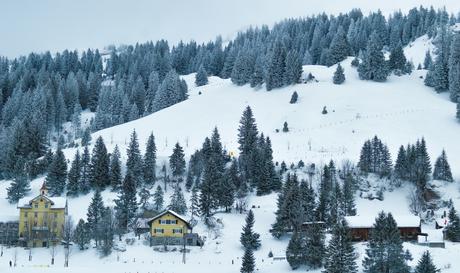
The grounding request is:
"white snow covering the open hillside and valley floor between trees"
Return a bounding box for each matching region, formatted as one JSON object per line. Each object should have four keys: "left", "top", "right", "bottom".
{"left": 0, "top": 37, "right": 460, "bottom": 273}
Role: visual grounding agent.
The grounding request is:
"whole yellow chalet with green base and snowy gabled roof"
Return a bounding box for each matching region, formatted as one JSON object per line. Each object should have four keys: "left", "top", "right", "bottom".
{"left": 147, "top": 210, "right": 202, "bottom": 245}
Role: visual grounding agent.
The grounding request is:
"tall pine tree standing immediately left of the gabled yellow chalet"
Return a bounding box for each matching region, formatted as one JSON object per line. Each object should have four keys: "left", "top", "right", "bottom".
{"left": 115, "top": 172, "right": 137, "bottom": 231}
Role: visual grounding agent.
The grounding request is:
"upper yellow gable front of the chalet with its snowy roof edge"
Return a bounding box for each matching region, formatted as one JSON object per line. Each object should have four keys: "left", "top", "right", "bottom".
{"left": 148, "top": 210, "right": 192, "bottom": 238}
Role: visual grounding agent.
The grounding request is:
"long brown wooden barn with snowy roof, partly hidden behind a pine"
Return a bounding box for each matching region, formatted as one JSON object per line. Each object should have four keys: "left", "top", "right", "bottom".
{"left": 345, "top": 215, "right": 422, "bottom": 242}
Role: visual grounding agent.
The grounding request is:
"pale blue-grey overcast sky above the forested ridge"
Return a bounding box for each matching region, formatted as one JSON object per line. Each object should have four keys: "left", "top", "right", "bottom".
{"left": 0, "top": 0, "right": 460, "bottom": 57}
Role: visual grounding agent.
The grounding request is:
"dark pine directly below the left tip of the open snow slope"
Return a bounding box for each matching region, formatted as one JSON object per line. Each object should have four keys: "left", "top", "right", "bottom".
{"left": 89, "top": 136, "right": 110, "bottom": 190}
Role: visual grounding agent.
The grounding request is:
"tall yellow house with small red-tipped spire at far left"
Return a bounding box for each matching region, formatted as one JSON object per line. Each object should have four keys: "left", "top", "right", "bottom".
{"left": 18, "top": 183, "right": 67, "bottom": 247}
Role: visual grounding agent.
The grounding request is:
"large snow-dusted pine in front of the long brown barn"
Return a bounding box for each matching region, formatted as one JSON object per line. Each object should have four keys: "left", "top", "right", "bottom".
{"left": 363, "top": 212, "right": 409, "bottom": 273}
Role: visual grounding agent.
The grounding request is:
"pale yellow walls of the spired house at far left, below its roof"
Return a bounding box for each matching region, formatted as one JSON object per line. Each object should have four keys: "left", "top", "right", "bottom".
{"left": 19, "top": 197, "right": 65, "bottom": 247}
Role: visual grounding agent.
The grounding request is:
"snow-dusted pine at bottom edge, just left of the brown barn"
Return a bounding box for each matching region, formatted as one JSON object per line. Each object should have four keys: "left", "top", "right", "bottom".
{"left": 324, "top": 221, "right": 358, "bottom": 273}
